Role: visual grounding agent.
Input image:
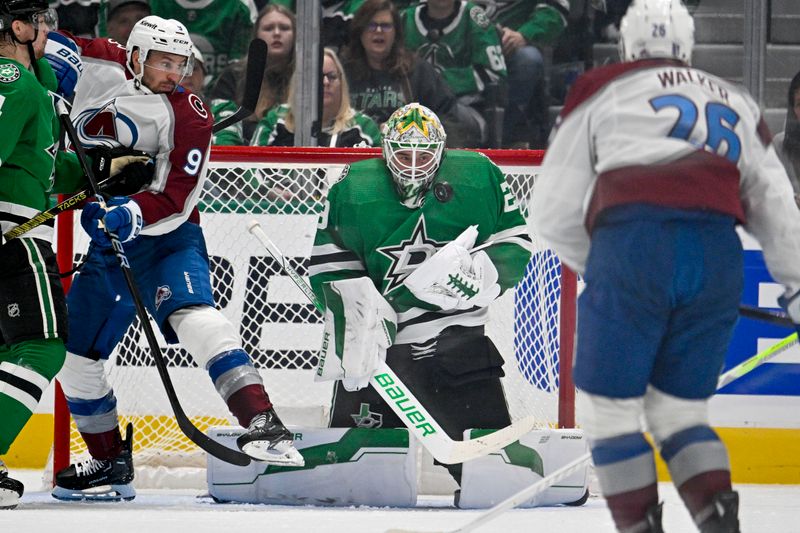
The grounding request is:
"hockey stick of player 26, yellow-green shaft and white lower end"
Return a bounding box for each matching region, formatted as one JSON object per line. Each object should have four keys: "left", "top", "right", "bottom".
{"left": 385, "top": 333, "right": 797, "bottom": 533}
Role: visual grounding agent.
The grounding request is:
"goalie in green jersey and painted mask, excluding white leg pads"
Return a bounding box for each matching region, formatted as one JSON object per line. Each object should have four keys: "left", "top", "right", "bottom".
{"left": 309, "top": 103, "right": 531, "bottom": 486}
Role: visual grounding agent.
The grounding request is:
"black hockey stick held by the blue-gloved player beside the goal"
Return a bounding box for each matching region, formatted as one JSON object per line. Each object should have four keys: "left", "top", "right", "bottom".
{"left": 56, "top": 101, "right": 250, "bottom": 466}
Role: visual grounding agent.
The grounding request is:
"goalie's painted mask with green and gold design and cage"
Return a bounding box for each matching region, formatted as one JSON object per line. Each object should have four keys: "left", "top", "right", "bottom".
{"left": 383, "top": 103, "right": 447, "bottom": 208}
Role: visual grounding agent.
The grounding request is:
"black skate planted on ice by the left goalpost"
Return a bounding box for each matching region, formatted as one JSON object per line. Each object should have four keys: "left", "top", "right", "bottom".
{"left": 52, "top": 424, "right": 136, "bottom": 501}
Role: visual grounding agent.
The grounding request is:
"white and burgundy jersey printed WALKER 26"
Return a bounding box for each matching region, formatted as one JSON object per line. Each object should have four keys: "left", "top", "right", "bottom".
{"left": 530, "top": 59, "right": 800, "bottom": 294}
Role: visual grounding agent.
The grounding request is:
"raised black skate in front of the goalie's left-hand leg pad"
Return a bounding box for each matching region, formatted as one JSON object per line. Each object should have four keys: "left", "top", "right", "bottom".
{"left": 236, "top": 409, "right": 305, "bottom": 466}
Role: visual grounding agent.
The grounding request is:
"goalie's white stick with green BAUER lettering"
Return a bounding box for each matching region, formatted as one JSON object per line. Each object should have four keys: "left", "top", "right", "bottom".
{"left": 247, "top": 220, "right": 535, "bottom": 464}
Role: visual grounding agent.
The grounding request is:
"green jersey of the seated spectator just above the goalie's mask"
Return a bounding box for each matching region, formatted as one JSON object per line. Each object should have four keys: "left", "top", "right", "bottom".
{"left": 403, "top": 0, "right": 506, "bottom": 96}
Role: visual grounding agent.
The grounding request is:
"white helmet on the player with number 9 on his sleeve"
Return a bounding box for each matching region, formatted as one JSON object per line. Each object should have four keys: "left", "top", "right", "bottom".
{"left": 130, "top": 15, "right": 194, "bottom": 82}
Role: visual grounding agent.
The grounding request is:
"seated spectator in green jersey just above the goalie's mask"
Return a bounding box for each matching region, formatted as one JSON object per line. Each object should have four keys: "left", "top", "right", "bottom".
{"left": 403, "top": 0, "right": 506, "bottom": 145}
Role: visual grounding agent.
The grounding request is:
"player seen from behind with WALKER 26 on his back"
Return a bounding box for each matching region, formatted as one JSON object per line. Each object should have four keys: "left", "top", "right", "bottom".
{"left": 530, "top": 0, "right": 800, "bottom": 532}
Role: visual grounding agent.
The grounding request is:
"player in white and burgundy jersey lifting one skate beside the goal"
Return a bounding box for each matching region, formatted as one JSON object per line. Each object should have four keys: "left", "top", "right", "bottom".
{"left": 47, "top": 16, "right": 302, "bottom": 499}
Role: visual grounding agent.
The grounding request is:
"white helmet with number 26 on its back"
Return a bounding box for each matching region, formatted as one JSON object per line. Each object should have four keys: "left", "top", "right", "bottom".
{"left": 619, "top": 0, "right": 694, "bottom": 63}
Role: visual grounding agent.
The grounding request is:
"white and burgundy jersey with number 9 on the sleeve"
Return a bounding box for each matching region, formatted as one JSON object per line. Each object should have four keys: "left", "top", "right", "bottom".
{"left": 69, "top": 31, "right": 213, "bottom": 235}
